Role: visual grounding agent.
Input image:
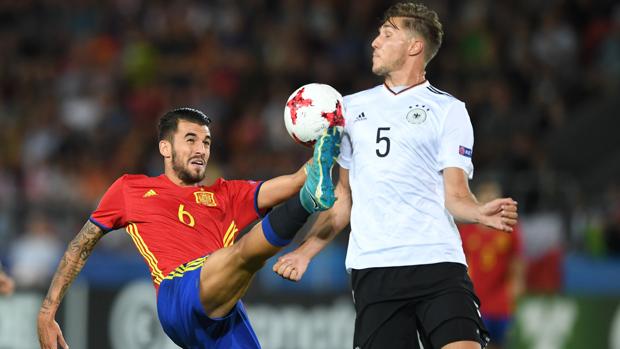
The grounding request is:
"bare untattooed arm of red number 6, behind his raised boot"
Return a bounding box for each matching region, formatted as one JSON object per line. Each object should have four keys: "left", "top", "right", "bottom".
{"left": 257, "top": 159, "right": 312, "bottom": 209}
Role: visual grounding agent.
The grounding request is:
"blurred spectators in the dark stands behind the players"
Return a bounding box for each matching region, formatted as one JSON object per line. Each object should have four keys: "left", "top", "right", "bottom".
{"left": 0, "top": 0, "right": 620, "bottom": 287}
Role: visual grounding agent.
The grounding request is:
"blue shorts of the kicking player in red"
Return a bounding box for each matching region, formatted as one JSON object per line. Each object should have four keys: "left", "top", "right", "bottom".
{"left": 157, "top": 258, "right": 260, "bottom": 349}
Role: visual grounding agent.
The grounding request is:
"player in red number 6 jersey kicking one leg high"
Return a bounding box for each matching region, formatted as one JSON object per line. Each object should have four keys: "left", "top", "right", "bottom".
{"left": 38, "top": 108, "right": 340, "bottom": 349}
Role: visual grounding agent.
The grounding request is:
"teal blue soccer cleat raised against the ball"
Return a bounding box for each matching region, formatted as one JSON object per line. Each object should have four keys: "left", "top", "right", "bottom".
{"left": 299, "top": 127, "right": 342, "bottom": 213}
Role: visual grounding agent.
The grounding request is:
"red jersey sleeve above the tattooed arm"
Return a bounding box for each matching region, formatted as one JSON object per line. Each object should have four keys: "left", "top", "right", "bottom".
{"left": 89, "top": 175, "right": 127, "bottom": 233}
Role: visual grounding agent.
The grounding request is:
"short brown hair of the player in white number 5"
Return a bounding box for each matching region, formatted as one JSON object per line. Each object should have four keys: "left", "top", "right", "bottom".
{"left": 381, "top": 1, "right": 443, "bottom": 63}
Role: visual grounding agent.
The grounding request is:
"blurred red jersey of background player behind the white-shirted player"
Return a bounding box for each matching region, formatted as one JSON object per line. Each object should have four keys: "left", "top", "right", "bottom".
{"left": 459, "top": 224, "right": 522, "bottom": 316}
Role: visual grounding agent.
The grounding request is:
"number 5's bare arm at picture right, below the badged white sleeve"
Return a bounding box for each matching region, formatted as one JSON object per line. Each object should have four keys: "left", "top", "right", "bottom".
{"left": 443, "top": 167, "right": 518, "bottom": 232}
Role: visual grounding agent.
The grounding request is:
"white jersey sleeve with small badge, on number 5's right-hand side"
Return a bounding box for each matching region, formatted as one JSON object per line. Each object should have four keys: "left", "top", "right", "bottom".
{"left": 438, "top": 101, "right": 474, "bottom": 179}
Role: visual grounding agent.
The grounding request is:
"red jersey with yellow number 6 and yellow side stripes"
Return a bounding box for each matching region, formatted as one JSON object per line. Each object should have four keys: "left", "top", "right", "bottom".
{"left": 90, "top": 175, "right": 260, "bottom": 289}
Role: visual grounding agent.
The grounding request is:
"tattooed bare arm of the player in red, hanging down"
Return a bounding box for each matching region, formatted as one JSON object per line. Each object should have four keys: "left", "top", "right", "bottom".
{"left": 37, "top": 221, "right": 103, "bottom": 349}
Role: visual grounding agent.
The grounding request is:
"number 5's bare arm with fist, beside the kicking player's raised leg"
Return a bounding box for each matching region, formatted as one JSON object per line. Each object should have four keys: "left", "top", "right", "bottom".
{"left": 273, "top": 167, "right": 352, "bottom": 281}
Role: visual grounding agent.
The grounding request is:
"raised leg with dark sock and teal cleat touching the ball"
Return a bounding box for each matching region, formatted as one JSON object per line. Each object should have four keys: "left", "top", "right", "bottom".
{"left": 200, "top": 128, "right": 341, "bottom": 318}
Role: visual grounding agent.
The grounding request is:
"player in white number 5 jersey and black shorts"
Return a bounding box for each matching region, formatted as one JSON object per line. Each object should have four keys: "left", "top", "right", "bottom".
{"left": 274, "top": 2, "right": 517, "bottom": 349}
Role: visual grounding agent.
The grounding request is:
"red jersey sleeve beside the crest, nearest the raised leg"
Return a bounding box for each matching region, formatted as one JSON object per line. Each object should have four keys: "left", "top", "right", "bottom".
{"left": 226, "top": 180, "right": 267, "bottom": 227}
